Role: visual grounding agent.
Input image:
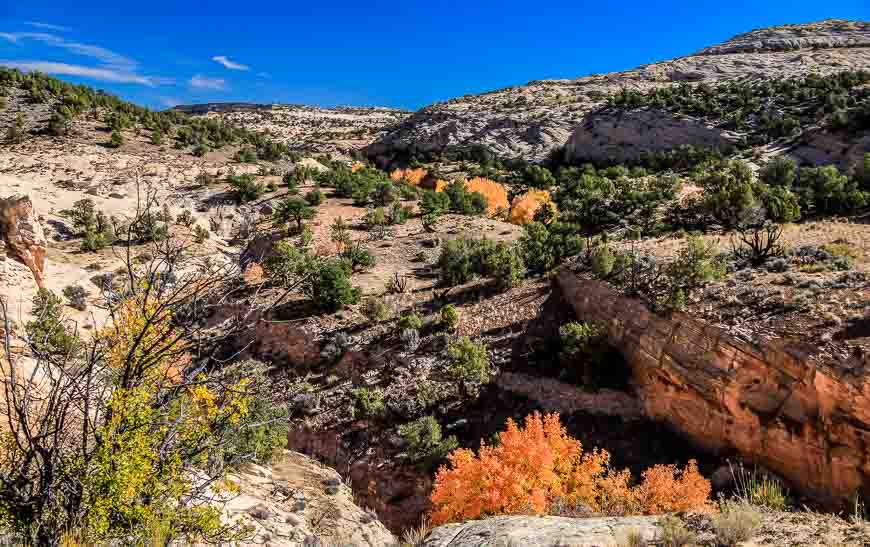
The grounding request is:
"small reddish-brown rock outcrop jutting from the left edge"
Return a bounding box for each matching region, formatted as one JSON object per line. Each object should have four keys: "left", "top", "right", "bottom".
{"left": 0, "top": 196, "right": 46, "bottom": 288}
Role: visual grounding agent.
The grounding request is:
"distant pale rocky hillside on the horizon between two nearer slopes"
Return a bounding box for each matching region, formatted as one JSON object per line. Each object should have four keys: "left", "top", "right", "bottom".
{"left": 181, "top": 103, "right": 410, "bottom": 156}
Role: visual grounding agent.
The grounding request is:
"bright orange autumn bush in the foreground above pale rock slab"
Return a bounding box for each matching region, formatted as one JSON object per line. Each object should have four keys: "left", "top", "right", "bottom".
{"left": 431, "top": 413, "right": 711, "bottom": 525}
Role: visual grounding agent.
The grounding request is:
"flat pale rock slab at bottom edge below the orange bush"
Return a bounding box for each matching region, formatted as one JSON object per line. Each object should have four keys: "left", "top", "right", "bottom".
{"left": 423, "top": 516, "right": 658, "bottom": 547}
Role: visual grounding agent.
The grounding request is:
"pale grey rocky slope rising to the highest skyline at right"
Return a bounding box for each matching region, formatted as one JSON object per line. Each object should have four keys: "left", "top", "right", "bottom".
{"left": 368, "top": 20, "right": 870, "bottom": 163}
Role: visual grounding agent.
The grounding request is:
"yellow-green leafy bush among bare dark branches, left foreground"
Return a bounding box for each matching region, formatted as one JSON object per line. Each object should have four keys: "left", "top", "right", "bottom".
{"left": 82, "top": 291, "right": 249, "bottom": 540}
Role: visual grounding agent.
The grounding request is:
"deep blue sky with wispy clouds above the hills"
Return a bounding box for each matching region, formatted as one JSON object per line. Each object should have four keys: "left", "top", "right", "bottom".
{"left": 0, "top": 0, "right": 870, "bottom": 110}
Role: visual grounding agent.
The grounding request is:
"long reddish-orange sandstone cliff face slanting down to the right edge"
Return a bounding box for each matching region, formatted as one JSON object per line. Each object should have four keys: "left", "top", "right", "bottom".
{"left": 559, "top": 271, "right": 870, "bottom": 503}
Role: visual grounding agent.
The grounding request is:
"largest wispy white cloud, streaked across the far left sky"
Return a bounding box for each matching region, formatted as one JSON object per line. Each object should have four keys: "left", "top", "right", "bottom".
{"left": 0, "top": 32, "right": 175, "bottom": 87}
